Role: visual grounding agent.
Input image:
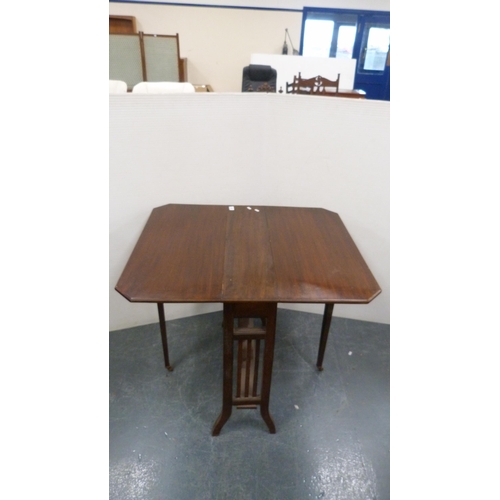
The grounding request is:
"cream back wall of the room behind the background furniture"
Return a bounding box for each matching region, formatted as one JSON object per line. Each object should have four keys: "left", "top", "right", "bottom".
{"left": 109, "top": 0, "right": 389, "bottom": 92}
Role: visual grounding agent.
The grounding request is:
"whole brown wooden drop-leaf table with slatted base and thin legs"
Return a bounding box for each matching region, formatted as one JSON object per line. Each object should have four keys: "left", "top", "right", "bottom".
{"left": 115, "top": 204, "right": 381, "bottom": 435}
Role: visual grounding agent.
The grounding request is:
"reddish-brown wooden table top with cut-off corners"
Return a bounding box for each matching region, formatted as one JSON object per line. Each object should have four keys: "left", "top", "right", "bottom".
{"left": 115, "top": 204, "right": 381, "bottom": 304}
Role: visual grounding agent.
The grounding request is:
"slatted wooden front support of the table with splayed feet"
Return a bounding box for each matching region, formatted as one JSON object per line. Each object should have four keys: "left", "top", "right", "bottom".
{"left": 212, "top": 302, "right": 277, "bottom": 436}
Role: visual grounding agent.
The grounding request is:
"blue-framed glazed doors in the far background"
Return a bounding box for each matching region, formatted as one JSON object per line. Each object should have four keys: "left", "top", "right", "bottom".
{"left": 300, "top": 7, "right": 390, "bottom": 101}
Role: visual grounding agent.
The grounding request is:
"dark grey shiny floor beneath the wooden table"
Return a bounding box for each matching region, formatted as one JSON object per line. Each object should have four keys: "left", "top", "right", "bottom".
{"left": 109, "top": 307, "right": 389, "bottom": 500}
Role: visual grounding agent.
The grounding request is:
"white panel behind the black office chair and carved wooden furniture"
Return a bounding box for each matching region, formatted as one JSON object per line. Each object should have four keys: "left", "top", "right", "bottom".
{"left": 250, "top": 54, "right": 356, "bottom": 92}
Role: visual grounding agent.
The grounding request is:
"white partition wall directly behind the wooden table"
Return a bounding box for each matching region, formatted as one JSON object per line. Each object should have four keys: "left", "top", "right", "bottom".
{"left": 109, "top": 93, "right": 390, "bottom": 330}
